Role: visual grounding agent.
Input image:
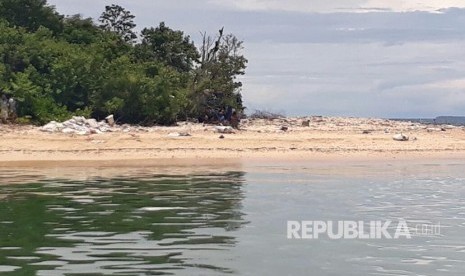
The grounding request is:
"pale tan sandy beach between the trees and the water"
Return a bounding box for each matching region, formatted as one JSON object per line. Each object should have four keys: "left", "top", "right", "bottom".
{"left": 0, "top": 116, "right": 465, "bottom": 165}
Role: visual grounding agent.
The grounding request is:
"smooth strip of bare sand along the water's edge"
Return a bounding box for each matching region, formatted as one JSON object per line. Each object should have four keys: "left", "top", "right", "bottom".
{"left": 0, "top": 148, "right": 465, "bottom": 164}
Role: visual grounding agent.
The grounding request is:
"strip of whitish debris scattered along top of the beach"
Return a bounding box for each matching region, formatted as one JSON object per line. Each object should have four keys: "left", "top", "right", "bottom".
{"left": 37, "top": 115, "right": 465, "bottom": 137}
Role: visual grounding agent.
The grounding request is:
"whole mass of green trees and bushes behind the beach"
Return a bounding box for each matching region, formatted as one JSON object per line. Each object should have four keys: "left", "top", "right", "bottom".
{"left": 0, "top": 0, "right": 247, "bottom": 125}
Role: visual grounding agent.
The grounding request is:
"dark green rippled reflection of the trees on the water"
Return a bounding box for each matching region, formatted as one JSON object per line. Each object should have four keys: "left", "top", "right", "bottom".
{"left": 0, "top": 172, "right": 246, "bottom": 275}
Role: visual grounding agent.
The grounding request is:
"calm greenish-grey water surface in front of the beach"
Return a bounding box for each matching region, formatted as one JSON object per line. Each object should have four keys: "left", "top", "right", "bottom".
{"left": 0, "top": 162, "right": 465, "bottom": 276}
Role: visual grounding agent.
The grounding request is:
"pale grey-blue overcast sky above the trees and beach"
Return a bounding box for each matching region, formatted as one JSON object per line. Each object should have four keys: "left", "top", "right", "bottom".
{"left": 48, "top": 0, "right": 465, "bottom": 117}
